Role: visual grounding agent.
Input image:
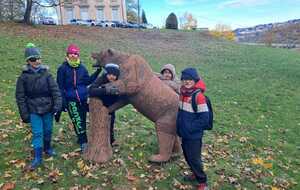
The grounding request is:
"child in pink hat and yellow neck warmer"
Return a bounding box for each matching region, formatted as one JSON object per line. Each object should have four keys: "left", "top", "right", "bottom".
{"left": 57, "top": 44, "right": 100, "bottom": 152}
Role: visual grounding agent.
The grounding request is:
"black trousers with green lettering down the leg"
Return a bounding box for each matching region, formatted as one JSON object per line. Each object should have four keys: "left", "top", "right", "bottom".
{"left": 67, "top": 101, "right": 87, "bottom": 144}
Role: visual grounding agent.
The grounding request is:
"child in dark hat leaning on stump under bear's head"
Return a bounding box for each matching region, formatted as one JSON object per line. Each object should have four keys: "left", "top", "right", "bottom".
{"left": 89, "top": 63, "right": 120, "bottom": 146}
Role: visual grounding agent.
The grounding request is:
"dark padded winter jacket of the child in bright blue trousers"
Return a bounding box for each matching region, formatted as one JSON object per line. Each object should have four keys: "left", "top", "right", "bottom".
{"left": 16, "top": 65, "right": 62, "bottom": 123}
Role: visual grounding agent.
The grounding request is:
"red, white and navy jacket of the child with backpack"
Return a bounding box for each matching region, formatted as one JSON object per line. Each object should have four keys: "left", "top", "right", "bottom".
{"left": 176, "top": 80, "right": 209, "bottom": 140}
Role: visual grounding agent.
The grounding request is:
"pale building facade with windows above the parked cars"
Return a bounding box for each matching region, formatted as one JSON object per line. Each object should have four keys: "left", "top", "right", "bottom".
{"left": 57, "top": 0, "right": 127, "bottom": 24}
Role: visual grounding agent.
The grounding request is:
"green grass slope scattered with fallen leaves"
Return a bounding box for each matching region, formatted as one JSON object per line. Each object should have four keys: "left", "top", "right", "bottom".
{"left": 0, "top": 23, "right": 300, "bottom": 190}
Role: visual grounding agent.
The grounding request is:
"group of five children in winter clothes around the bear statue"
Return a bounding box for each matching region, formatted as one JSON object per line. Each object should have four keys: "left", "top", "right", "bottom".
{"left": 16, "top": 43, "right": 208, "bottom": 190}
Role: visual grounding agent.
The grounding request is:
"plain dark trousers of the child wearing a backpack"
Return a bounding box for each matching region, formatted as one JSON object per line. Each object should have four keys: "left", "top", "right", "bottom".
{"left": 181, "top": 139, "right": 207, "bottom": 183}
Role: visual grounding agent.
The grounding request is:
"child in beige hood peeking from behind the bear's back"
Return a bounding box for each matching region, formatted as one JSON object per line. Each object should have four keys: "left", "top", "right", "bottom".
{"left": 158, "top": 64, "right": 180, "bottom": 94}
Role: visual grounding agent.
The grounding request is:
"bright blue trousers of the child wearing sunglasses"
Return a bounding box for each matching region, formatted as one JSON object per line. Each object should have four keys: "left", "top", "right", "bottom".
{"left": 30, "top": 113, "right": 53, "bottom": 149}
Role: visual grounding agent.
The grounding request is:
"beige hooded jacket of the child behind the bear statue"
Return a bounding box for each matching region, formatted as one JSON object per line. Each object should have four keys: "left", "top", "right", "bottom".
{"left": 158, "top": 64, "right": 180, "bottom": 94}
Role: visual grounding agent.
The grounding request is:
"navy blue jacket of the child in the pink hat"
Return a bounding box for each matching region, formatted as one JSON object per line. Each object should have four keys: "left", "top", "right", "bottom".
{"left": 57, "top": 61, "right": 100, "bottom": 106}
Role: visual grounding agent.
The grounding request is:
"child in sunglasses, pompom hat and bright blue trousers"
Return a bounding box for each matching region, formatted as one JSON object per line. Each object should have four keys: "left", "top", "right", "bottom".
{"left": 16, "top": 43, "right": 62, "bottom": 170}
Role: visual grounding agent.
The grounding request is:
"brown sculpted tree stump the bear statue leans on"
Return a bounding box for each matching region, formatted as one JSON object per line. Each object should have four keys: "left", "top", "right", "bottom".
{"left": 84, "top": 98, "right": 112, "bottom": 163}
